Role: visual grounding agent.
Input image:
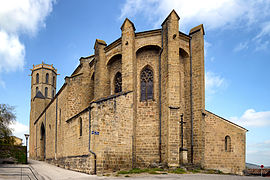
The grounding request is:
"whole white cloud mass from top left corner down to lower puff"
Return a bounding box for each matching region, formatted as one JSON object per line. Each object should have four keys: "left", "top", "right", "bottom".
{"left": 0, "top": 0, "right": 54, "bottom": 72}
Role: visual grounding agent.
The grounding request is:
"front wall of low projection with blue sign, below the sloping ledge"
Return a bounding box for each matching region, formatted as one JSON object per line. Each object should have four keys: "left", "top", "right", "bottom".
{"left": 90, "top": 92, "right": 133, "bottom": 173}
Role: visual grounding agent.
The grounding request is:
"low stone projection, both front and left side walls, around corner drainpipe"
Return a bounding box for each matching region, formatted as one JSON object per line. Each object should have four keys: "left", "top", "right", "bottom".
{"left": 46, "top": 92, "right": 133, "bottom": 174}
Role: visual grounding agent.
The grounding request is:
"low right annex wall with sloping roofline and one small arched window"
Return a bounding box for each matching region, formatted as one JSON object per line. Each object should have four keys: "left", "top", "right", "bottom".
{"left": 204, "top": 111, "right": 246, "bottom": 174}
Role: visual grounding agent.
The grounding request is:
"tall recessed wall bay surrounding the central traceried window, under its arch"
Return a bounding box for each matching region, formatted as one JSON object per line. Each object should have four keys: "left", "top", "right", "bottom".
{"left": 136, "top": 46, "right": 160, "bottom": 167}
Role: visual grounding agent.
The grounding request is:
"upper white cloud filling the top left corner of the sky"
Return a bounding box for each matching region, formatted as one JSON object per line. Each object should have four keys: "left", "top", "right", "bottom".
{"left": 0, "top": 0, "right": 54, "bottom": 33}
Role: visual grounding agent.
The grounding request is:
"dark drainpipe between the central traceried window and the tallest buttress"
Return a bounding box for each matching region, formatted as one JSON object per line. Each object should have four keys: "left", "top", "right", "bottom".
{"left": 158, "top": 28, "right": 163, "bottom": 163}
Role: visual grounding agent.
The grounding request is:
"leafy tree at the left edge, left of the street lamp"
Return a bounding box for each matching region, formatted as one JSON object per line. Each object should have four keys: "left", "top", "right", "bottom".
{"left": 0, "top": 104, "right": 16, "bottom": 144}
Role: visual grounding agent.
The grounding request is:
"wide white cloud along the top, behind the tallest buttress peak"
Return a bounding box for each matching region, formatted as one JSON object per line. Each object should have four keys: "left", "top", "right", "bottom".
{"left": 120, "top": 0, "right": 270, "bottom": 30}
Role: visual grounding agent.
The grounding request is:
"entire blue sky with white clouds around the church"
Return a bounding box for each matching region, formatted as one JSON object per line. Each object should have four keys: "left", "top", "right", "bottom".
{"left": 0, "top": 0, "right": 270, "bottom": 165}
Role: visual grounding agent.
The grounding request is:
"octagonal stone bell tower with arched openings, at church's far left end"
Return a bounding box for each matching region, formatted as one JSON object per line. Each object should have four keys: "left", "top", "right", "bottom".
{"left": 29, "top": 62, "right": 57, "bottom": 158}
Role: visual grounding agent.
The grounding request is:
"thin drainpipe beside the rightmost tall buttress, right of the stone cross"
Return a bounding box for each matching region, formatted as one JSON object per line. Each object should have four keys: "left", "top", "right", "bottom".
{"left": 189, "top": 37, "right": 193, "bottom": 164}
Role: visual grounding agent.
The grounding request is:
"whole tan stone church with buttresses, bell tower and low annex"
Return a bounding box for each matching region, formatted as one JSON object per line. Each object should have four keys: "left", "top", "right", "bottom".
{"left": 30, "top": 10, "right": 247, "bottom": 174}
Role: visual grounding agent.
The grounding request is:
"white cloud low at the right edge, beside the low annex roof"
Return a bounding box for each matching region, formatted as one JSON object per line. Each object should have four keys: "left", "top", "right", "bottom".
{"left": 230, "top": 109, "right": 270, "bottom": 127}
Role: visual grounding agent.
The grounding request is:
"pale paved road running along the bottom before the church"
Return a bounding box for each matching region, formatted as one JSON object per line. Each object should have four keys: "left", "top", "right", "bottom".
{"left": 0, "top": 160, "right": 270, "bottom": 180}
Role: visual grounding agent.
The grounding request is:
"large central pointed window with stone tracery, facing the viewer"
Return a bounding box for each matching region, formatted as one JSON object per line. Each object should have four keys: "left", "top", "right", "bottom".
{"left": 141, "top": 67, "right": 154, "bottom": 101}
